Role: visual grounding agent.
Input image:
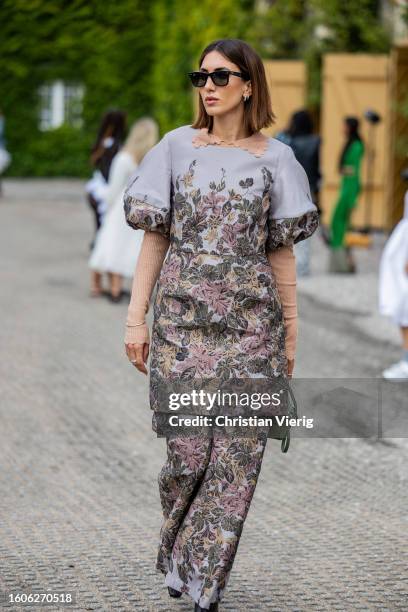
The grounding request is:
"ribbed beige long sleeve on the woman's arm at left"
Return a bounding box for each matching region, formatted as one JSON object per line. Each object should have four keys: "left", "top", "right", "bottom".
{"left": 125, "top": 231, "right": 170, "bottom": 344}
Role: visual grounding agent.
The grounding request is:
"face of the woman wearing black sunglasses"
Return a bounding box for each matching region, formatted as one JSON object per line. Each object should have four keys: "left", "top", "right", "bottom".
{"left": 199, "top": 51, "right": 251, "bottom": 117}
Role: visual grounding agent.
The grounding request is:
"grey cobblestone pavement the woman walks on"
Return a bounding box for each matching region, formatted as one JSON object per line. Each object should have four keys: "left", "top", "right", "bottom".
{"left": 0, "top": 180, "right": 408, "bottom": 612}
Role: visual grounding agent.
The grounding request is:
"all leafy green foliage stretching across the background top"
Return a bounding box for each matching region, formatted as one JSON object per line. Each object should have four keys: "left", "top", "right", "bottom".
{"left": 0, "top": 0, "right": 392, "bottom": 176}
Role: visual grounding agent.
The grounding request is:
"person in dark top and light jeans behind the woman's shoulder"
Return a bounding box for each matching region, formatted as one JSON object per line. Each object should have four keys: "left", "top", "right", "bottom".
{"left": 275, "top": 110, "right": 321, "bottom": 276}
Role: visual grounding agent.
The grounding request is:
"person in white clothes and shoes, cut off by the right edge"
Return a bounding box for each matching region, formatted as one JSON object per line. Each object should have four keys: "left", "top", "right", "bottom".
{"left": 378, "top": 170, "right": 408, "bottom": 379}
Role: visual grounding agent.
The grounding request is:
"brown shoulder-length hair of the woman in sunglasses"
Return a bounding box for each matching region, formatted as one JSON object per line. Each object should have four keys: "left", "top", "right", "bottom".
{"left": 191, "top": 38, "right": 276, "bottom": 135}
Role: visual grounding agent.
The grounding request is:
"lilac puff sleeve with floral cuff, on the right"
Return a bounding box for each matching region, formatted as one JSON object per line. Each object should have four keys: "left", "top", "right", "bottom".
{"left": 265, "top": 145, "right": 319, "bottom": 252}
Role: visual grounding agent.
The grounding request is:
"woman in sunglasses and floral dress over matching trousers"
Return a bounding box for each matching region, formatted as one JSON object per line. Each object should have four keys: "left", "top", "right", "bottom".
{"left": 124, "top": 39, "right": 318, "bottom": 612}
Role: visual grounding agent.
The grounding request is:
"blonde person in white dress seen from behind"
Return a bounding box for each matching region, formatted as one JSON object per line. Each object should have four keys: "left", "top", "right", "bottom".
{"left": 89, "top": 117, "right": 159, "bottom": 302}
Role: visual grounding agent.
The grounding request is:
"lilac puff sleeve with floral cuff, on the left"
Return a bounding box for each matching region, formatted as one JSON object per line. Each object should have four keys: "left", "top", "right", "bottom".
{"left": 123, "top": 134, "right": 171, "bottom": 238}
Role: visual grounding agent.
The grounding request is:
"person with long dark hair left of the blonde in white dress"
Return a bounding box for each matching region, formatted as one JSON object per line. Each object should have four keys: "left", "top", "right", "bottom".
{"left": 85, "top": 110, "right": 126, "bottom": 297}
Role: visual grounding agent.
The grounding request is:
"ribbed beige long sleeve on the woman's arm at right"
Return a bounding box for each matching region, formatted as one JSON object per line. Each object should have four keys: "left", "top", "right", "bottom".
{"left": 267, "top": 245, "right": 297, "bottom": 359}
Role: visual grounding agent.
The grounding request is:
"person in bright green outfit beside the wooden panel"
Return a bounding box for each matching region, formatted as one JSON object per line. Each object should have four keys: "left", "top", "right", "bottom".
{"left": 329, "top": 117, "right": 364, "bottom": 272}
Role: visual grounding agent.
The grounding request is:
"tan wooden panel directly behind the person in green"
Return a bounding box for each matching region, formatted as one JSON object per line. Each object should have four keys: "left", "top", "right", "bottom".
{"left": 321, "top": 54, "right": 390, "bottom": 229}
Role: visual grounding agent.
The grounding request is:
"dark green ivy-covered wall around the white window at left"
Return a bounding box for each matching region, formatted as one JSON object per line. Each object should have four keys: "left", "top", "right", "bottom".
{"left": 0, "top": 0, "right": 153, "bottom": 176}
